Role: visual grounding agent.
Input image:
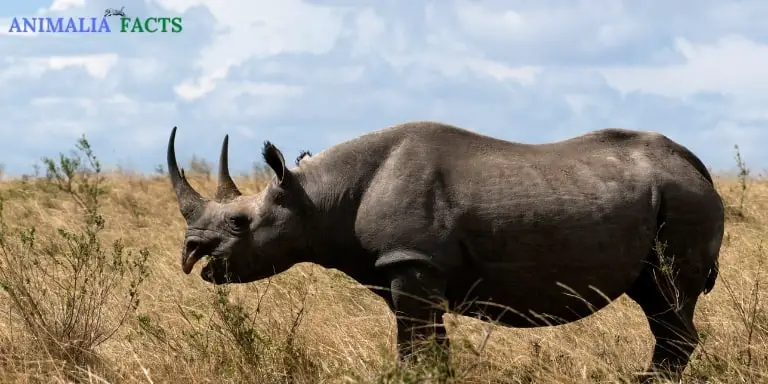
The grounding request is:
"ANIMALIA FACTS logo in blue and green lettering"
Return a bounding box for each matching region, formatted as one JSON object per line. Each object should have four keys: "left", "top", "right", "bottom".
{"left": 8, "top": 7, "right": 184, "bottom": 33}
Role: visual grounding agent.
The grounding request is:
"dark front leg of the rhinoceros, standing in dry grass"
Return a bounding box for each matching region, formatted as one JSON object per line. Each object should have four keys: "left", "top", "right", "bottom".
{"left": 377, "top": 252, "right": 449, "bottom": 361}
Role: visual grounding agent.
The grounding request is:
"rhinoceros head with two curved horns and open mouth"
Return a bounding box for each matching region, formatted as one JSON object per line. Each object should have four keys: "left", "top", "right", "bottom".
{"left": 168, "top": 127, "right": 310, "bottom": 284}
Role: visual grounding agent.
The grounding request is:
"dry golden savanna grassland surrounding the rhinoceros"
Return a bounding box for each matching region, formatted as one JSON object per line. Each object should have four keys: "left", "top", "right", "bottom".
{"left": 0, "top": 141, "right": 768, "bottom": 383}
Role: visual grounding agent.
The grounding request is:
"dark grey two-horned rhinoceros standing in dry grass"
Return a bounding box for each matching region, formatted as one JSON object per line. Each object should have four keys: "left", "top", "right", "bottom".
{"left": 168, "top": 121, "right": 724, "bottom": 378}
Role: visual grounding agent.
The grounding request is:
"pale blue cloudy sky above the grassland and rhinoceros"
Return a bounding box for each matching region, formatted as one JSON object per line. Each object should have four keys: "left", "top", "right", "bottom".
{"left": 0, "top": 0, "right": 768, "bottom": 175}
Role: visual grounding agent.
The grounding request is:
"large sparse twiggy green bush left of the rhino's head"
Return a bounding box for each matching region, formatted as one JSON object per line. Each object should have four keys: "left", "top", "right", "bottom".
{"left": 0, "top": 137, "right": 149, "bottom": 373}
